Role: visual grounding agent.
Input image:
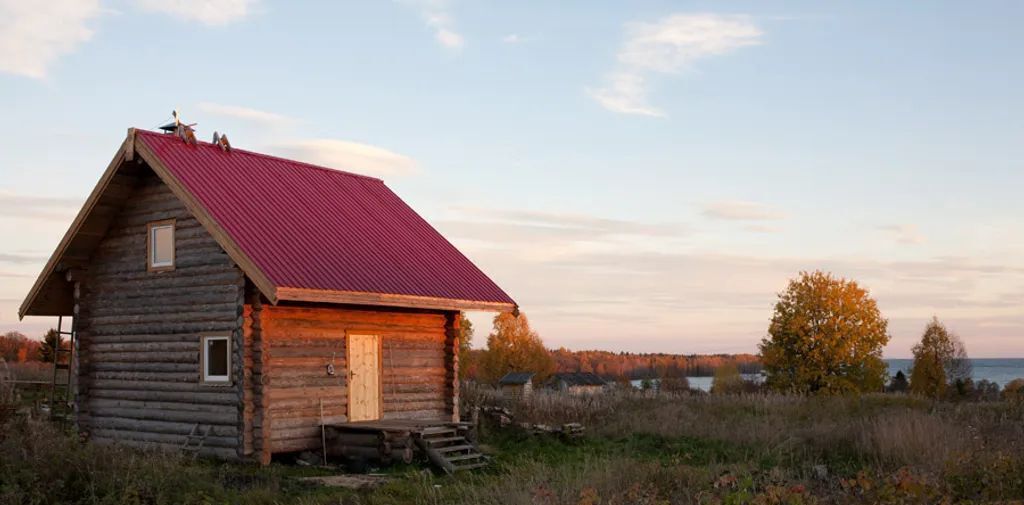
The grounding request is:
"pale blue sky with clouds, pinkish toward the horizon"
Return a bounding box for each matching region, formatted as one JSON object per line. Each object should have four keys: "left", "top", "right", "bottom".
{"left": 0, "top": 0, "right": 1024, "bottom": 356}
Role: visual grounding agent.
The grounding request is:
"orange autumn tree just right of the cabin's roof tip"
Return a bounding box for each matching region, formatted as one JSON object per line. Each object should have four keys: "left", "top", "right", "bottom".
{"left": 477, "top": 312, "right": 555, "bottom": 383}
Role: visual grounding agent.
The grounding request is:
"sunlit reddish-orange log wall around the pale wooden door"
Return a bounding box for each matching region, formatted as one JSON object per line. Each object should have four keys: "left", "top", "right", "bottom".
{"left": 246, "top": 304, "right": 453, "bottom": 453}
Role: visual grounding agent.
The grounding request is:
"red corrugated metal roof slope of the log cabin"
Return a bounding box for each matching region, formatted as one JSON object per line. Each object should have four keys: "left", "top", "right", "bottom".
{"left": 136, "top": 130, "right": 515, "bottom": 304}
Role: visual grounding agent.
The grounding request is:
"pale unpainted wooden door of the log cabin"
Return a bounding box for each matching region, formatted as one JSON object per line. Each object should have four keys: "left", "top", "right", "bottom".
{"left": 348, "top": 334, "right": 383, "bottom": 421}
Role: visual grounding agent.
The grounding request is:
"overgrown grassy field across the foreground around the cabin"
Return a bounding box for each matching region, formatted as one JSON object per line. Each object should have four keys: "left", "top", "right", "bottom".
{"left": 0, "top": 387, "right": 1024, "bottom": 505}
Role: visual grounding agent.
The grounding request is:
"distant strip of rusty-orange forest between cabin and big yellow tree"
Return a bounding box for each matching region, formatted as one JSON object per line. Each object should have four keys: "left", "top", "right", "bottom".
{"left": 463, "top": 347, "right": 761, "bottom": 379}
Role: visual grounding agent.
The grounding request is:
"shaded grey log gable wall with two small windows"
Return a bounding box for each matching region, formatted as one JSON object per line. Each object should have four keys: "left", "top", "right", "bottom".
{"left": 76, "top": 174, "right": 245, "bottom": 458}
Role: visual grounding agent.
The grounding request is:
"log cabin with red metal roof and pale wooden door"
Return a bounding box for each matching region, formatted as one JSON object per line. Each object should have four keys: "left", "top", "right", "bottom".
{"left": 19, "top": 128, "right": 516, "bottom": 464}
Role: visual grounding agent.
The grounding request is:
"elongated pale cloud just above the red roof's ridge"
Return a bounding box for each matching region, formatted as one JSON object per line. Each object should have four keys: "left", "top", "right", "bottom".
{"left": 273, "top": 138, "right": 417, "bottom": 177}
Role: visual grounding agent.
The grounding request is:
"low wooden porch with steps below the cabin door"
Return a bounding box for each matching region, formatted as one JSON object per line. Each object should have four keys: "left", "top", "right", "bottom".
{"left": 324, "top": 419, "right": 487, "bottom": 473}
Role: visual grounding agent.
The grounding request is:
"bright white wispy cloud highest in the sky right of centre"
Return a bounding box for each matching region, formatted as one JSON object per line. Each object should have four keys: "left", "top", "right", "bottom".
{"left": 587, "top": 13, "right": 762, "bottom": 117}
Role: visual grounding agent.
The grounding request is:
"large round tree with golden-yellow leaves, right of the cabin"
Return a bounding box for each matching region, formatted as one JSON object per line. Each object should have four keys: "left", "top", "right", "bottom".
{"left": 760, "top": 270, "right": 889, "bottom": 394}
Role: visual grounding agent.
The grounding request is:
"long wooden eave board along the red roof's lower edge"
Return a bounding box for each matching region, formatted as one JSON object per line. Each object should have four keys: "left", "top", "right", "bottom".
{"left": 278, "top": 287, "right": 516, "bottom": 312}
